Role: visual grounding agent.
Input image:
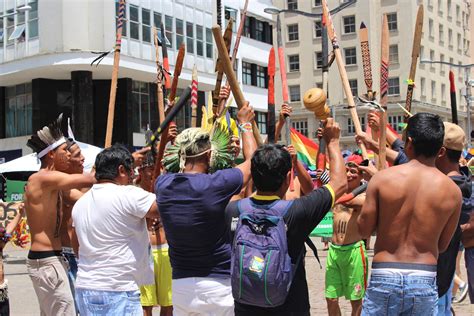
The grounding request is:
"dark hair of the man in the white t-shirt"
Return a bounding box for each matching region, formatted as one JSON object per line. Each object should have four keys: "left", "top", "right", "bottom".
{"left": 95, "top": 144, "right": 133, "bottom": 180}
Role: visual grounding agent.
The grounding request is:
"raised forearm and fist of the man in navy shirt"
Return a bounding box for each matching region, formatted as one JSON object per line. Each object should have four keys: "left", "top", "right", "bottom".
{"left": 237, "top": 102, "right": 257, "bottom": 187}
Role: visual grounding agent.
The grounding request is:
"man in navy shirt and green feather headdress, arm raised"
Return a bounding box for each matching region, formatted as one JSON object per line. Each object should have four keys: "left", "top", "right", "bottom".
{"left": 155, "top": 103, "right": 257, "bottom": 315}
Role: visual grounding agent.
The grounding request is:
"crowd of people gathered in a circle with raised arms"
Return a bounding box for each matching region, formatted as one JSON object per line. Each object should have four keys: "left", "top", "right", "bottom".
{"left": 5, "top": 87, "right": 474, "bottom": 315}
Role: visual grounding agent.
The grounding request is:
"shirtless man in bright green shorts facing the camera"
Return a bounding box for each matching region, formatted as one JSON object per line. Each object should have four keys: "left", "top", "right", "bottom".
{"left": 325, "top": 155, "right": 368, "bottom": 316}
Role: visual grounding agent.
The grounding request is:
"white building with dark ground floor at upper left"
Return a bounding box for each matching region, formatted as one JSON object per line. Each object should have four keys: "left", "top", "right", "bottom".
{"left": 0, "top": 0, "right": 272, "bottom": 161}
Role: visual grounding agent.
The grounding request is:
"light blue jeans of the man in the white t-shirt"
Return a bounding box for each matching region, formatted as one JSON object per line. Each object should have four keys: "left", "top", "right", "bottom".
{"left": 76, "top": 288, "right": 143, "bottom": 316}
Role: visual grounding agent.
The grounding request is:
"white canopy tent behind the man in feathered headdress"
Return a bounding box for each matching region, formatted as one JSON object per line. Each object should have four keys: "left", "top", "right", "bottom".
{"left": 0, "top": 141, "right": 102, "bottom": 173}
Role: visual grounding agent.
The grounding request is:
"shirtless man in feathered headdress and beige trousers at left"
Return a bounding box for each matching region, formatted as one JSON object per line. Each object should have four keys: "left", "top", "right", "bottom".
{"left": 25, "top": 116, "right": 95, "bottom": 315}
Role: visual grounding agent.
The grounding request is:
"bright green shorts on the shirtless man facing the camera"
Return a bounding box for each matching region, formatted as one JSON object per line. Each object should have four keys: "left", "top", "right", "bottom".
{"left": 325, "top": 241, "right": 368, "bottom": 301}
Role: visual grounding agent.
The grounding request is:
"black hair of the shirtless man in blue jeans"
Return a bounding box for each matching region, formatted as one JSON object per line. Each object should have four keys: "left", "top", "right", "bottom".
{"left": 407, "top": 113, "right": 444, "bottom": 158}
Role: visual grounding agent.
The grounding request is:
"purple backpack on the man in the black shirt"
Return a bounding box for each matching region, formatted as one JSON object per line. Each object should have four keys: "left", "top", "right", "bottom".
{"left": 231, "top": 198, "right": 301, "bottom": 307}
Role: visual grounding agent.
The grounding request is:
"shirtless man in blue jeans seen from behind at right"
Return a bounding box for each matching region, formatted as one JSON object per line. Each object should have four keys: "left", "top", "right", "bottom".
{"left": 358, "top": 113, "right": 461, "bottom": 315}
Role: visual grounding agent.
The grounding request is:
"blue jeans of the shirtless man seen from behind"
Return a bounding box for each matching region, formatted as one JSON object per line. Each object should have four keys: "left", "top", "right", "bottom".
{"left": 362, "top": 271, "right": 438, "bottom": 316}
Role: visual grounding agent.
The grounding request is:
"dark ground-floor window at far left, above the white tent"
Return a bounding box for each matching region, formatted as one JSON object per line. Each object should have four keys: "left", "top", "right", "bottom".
{"left": 5, "top": 83, "right": 33, "bottom": 137}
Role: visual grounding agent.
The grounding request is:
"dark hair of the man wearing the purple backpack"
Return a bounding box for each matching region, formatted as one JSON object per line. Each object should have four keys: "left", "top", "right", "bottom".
{"left": 251, "top": 144, "right": 291, "bottom": 192}
